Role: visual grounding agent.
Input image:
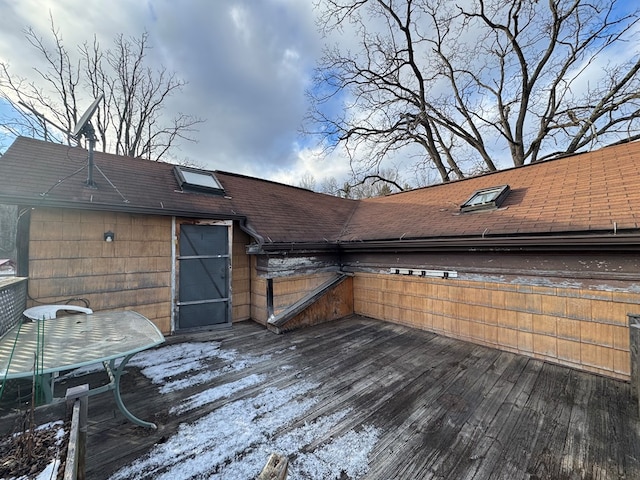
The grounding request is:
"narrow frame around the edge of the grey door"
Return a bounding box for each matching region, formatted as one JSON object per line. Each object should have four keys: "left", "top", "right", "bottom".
{"left": 171, "top": 217, "right": 233, "bottom": 333}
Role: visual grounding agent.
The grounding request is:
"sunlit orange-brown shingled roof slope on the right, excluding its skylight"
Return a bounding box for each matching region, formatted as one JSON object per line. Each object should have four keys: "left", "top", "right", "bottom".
{"left": 341, "top": 142, "right": 640, "bottom": 241}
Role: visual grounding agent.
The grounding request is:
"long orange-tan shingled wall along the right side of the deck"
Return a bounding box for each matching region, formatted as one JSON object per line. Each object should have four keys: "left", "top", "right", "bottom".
{"left": 353, "top": 272, "right": 640, "bottom": 380}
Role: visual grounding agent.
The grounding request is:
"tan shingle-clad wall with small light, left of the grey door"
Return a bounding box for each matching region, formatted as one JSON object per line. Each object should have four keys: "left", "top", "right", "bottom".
{"left": 29, "top": 208, "right": 171, "bottom": 333}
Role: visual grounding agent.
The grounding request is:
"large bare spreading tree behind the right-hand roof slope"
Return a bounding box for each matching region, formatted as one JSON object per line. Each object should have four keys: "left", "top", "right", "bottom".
{"left": 305, "top": 0, "right": 640, "bottom": 181}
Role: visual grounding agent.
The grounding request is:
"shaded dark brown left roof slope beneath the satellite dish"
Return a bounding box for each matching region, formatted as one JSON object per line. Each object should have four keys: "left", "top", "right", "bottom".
{"left": 0, "top": 137, "right": 356, "bottom": 243}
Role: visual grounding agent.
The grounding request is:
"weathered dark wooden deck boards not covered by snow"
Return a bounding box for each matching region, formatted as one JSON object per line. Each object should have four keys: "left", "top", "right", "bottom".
{"left": 1, "top": 317, "right": 640, "bottom": 480}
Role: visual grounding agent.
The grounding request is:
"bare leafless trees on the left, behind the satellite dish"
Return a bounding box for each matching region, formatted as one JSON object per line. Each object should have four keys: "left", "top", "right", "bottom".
{"left": 0, "top": 19, "right": 204, "bottom": 160}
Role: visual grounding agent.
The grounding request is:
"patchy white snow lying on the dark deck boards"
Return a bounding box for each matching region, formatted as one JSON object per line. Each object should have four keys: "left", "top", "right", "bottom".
{"left": 111, "top": 342, "right": 379, "bottom": 480}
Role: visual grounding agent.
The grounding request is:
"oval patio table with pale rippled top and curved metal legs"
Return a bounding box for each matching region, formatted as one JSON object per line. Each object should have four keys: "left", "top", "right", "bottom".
{"left": 0, "top": 311, "right": 164, "bottom": 428}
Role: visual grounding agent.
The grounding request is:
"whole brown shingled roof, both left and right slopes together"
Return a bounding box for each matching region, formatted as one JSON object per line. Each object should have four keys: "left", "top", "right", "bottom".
{"left": 0, "top": 138, "right": 640, "bottom": 248}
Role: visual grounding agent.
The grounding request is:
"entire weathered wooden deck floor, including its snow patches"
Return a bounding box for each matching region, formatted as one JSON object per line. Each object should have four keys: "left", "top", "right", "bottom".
{"left": 1, "top": 316, "right": 640, "bottom": 480}
